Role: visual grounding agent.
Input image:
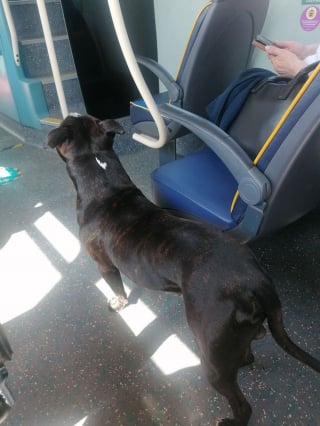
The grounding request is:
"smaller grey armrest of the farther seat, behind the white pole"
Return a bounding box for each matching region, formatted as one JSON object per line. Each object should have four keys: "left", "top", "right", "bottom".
{"left": 136, "top": 55, "right": 182, "bottom": 102}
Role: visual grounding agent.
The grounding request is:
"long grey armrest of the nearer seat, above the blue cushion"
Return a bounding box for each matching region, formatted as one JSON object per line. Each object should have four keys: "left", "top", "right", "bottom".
{"left": 159, "top": 104, "right": 271, "bottom": 205}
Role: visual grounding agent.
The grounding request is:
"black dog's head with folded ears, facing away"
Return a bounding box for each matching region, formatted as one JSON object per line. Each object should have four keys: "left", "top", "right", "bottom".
{"left": 45, "top": 115, "right": 124, "bottom": 160}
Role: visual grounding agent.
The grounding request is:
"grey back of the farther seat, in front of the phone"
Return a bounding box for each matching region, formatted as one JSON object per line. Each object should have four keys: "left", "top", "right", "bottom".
{"left": 177, "top": 0, "right": 269, "bottom": 116}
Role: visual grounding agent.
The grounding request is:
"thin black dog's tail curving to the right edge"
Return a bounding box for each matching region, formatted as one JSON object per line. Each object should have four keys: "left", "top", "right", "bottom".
{"left": 258, "top": 287, "right": 320, "bottom": 373}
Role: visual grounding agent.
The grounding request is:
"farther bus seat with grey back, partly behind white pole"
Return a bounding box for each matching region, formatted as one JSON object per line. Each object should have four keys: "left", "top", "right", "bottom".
{"left": 130, "top": 0, "right": 269, "bottom": 159}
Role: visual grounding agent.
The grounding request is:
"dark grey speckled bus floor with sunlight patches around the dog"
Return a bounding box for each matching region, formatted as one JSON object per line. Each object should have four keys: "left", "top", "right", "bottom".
{"left": 0, "top": 127, "right": 320, "bottom": 426}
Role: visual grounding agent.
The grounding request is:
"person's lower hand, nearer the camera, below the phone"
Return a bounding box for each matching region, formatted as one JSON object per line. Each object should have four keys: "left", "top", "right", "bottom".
{"left": 266, "top": 45, "right": 306, "bottom": 77}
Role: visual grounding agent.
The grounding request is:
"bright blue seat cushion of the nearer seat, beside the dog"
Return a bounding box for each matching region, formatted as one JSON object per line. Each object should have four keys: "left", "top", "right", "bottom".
{"left": 151, "top": 149, "right": 241, "bottom": 229}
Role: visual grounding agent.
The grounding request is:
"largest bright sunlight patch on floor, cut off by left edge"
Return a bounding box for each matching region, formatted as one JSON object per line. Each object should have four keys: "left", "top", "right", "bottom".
{"left": 0, "top": 231, "right": 62, "bottom": 324}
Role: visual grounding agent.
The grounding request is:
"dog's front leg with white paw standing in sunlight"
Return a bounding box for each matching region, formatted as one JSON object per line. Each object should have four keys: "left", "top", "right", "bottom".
{"left": 98, "top": 263, "right": 128, "bottom": 312}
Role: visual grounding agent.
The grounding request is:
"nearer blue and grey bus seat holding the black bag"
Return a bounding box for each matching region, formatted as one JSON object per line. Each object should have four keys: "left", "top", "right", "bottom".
{"left": 152, "top": 65, "right": 320, "bottom": 242}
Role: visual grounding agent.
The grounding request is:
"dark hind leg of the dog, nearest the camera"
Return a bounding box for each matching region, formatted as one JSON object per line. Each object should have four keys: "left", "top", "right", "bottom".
{"left": 187, "top": 304, "right": 257, "bottom": 426}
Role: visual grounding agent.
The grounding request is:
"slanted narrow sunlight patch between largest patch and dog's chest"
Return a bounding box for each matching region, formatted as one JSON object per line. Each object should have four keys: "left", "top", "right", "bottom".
{"left": 34, "top": 212, "right": 81, "bottom": 263}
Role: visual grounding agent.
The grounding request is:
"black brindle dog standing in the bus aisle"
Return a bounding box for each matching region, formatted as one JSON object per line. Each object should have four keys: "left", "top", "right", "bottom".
{"left": 47, "top": 116, "right": 320, "bottom": 426}
